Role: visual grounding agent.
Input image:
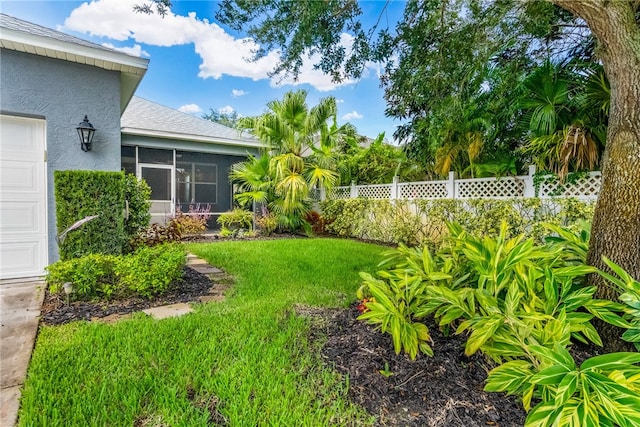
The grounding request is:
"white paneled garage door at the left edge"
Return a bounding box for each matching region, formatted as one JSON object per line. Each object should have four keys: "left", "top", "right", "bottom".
{"left": 0, "top": 115, "right": 47, "bottom": 279}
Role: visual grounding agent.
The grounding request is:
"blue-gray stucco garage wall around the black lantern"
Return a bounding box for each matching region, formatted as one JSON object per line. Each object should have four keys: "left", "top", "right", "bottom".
{"left": 0, "top": 49, "right": 121, "bottom": 262}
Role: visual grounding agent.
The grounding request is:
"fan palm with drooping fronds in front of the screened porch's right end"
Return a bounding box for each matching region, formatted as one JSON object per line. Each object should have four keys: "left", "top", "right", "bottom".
{"left": 232, "top": 90, "right": 344, "bottom": 229}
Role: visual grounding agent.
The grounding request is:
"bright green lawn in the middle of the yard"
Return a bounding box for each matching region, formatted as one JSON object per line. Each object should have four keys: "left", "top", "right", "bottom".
{"left": 19, "top": 239, "right": 385, "bottom": 426}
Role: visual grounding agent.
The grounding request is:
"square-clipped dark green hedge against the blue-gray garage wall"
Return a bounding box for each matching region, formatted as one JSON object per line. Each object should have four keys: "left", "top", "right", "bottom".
{"left": 54, "top": 171, "right": 127, "bottom": 260}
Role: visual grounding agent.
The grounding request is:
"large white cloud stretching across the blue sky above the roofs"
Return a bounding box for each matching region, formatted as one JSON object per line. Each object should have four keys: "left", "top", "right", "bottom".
{"left": 61, "top": 0, "right": 364, "bottom": 96}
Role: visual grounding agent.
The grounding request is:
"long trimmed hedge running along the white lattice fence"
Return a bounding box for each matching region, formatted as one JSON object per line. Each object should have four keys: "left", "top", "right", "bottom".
{"left": 320, "top": 198, "right": 594, "bottom": 246}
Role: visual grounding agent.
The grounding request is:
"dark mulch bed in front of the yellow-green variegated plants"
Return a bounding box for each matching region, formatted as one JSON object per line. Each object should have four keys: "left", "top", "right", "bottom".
{"left": 322, "top": 306, "right": 525, "bottom": 427}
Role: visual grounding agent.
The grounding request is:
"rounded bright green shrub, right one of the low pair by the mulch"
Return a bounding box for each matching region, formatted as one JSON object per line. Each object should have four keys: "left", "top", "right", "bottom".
{"left": 115, "top": 245, "right": 185, "bottom": 297}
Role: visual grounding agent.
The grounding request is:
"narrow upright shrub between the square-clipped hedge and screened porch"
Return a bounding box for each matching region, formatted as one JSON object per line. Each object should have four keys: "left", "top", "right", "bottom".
{"left": 124, "top": 174, "right": 151, "bottom": 252}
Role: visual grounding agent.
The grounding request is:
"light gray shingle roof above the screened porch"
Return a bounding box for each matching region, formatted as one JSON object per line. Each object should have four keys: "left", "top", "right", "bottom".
{"left": 120, "top": 96, "right": 259, "bottom": 146}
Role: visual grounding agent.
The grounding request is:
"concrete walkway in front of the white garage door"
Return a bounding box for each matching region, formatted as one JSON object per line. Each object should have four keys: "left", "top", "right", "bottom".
{"left": 0, "top": 281, "right": 44, "bottom": 427}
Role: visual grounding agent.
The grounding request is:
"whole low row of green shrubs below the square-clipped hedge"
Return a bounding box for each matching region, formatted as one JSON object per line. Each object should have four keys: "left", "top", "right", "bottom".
{"left": 46, "top": 245, "right": 185, "bottom": 300}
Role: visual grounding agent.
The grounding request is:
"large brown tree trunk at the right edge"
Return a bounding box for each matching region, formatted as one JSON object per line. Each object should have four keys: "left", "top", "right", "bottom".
{"left": 552, "top": 0, "right": 640, "bottom": 350}
